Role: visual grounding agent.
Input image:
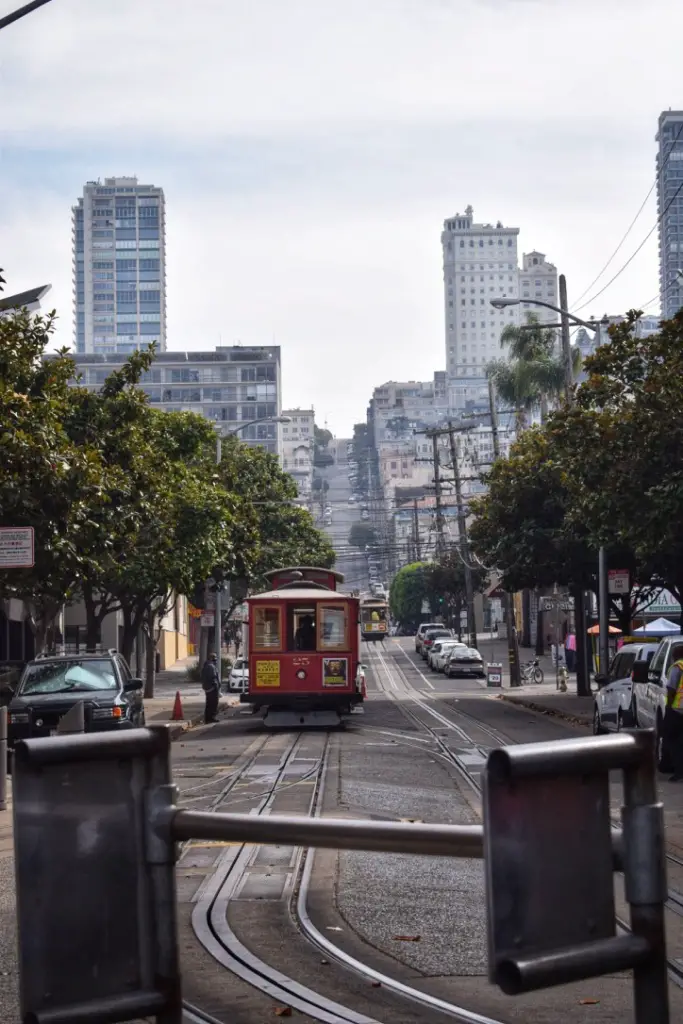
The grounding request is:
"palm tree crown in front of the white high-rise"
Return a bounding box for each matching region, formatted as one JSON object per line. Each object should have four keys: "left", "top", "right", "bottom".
{"left": 486, "top": 313, "right": 581, "bottom": 423}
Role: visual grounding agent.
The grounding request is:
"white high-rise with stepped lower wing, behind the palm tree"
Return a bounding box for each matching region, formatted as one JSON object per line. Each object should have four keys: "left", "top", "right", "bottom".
{"left": 441, "top": 206, "right": 557, "bottom": 411}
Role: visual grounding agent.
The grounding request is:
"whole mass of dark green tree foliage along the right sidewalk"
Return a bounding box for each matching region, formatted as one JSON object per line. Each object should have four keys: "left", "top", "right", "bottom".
{"left": 471, "top": 303, "right": 683, "bottom": 624}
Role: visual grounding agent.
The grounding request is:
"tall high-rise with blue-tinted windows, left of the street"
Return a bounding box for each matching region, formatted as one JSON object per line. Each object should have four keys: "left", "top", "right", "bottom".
{"left": 73, "top": 177, "right": 166, "bottom": 354}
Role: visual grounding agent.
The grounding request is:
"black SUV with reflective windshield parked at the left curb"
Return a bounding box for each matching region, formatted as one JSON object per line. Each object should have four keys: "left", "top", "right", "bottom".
{"left": 7, "top": 650, "right": 144, "bottom": 748}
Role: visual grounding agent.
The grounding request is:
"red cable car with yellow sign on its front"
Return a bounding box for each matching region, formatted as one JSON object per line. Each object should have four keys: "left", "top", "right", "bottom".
{"left": 240, "top": 566, "right": 365, "bottom": 727}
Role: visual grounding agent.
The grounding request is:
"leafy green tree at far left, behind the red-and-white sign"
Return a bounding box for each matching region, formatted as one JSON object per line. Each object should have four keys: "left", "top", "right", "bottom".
{"left": 0, "top": 310, "right": 105, "bottom": 651}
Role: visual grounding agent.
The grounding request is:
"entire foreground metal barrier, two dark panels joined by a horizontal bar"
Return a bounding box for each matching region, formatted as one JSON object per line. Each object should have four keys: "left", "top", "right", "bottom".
{"left": 13, "top": 727, "right": 669, "bottom": 1024}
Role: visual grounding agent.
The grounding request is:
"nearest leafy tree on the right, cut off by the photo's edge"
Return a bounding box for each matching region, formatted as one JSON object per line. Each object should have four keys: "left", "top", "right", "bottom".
{"left": 551, "top": 310, "right": 683, "bottom": 604}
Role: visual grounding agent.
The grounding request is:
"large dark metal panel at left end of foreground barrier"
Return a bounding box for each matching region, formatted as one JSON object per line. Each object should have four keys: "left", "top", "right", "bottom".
{"left": 13, "top": 728, "right": 181, "bottom": 1024}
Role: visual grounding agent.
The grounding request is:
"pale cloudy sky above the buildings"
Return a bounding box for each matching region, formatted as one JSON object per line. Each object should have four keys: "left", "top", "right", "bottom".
{"left": 0, "top": 0, "right": 683, "bottom": 436}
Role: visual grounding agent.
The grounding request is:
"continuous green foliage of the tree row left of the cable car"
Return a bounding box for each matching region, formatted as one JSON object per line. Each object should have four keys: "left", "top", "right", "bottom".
{"left": 0, "top": 288, "right": 334, "bottom": 659}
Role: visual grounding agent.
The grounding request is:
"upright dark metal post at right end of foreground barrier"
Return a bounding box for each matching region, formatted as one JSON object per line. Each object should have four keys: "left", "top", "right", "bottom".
{"left": 622, "top": 732, "right": 670, "bottom": 1024}
